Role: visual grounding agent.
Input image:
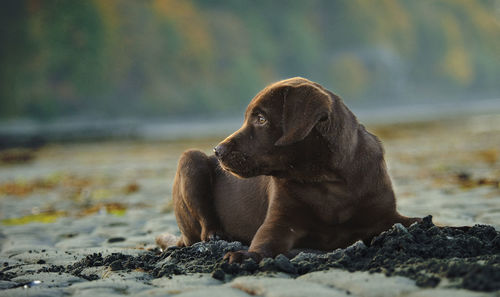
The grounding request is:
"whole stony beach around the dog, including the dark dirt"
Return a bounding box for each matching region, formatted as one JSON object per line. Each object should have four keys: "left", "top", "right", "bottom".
{"left": 0, "top": 115, "right": 500, "bottom": 296}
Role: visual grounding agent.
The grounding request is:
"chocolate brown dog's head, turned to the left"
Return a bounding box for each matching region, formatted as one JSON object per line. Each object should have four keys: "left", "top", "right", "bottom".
{"left": 214, "top": 78, "right": 332, "bottom": 177}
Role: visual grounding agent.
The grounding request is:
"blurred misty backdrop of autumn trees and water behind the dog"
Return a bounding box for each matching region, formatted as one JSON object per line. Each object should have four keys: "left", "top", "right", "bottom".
{"left": 0, "top": 0, "right": 500, "bottom": 139}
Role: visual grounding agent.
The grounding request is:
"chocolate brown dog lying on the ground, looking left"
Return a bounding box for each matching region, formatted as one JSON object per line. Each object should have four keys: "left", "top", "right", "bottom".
{"left": 159, "top": 77, "right": 419, "bottom": 262}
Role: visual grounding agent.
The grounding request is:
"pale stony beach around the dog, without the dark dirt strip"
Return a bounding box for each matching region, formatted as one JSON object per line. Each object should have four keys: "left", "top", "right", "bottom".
{"left": 0, "top": 114, "right": 500, "bottom": 296}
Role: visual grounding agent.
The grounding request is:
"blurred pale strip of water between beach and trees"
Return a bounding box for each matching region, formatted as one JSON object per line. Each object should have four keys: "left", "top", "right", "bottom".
{"left": 0, "top": 98, "right": 500, "bottom": 149}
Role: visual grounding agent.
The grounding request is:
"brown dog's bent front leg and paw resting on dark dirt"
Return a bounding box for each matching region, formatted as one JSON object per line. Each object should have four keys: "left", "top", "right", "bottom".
{"left": 224, "top": 215, "right": 304, "bottom": 263}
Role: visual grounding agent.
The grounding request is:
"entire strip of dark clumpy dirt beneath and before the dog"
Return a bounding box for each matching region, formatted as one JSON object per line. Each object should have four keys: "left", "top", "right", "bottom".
{"left": 0, "top": 216, "right": 500, "bottom": 291}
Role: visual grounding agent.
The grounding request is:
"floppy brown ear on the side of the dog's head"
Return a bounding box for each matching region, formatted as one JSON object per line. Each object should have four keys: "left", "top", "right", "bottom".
{"left": 275, "top": 83, "right": 332, "bottom": 146}
